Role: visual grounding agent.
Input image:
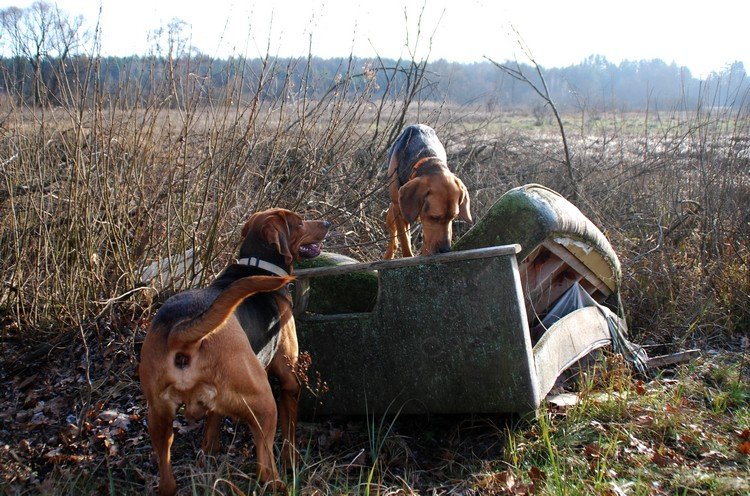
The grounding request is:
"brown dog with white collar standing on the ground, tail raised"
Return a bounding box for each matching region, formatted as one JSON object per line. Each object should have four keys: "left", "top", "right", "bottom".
{"left": 139, "top": 209, "right": 330, "bottom": 495}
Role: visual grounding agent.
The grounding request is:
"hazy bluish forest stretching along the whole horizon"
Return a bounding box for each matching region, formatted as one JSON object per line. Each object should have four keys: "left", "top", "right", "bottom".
{"left": 0, "top": 54, "right": 750, "bottom": 112}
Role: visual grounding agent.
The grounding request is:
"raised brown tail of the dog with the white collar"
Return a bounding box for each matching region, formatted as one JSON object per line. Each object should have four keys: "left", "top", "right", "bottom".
{"left": 167, "top": 276, "right": 294, "bottom": 349}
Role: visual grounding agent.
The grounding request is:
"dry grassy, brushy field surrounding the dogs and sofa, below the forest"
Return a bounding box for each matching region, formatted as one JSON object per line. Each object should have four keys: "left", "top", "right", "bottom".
{"left": 0, "top": 54, "right": 750, "bottom": 495}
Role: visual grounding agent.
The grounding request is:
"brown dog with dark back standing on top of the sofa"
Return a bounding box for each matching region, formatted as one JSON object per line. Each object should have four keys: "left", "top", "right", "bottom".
{"left": 383, "top": 124, "right": 472, "bottom": 259}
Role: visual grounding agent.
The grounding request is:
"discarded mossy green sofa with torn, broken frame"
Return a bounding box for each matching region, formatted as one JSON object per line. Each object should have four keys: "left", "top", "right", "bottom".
{"left": 295, "top": 184, "right": 645, "bottom": 415}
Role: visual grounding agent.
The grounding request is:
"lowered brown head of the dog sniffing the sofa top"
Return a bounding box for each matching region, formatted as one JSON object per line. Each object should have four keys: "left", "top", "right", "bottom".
{"left": 398, "top": 171, "right": 473, "bottom": 255}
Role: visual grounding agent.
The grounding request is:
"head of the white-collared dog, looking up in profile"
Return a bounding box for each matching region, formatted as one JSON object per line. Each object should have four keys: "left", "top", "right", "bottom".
{"left": 240, "top": 208, "right": 331, "bottom": 267}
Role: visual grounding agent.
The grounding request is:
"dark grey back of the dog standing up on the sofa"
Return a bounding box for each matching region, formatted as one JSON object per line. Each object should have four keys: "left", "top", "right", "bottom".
{"left": 388, "top": 124, "right": 448, "bottom": 185}
